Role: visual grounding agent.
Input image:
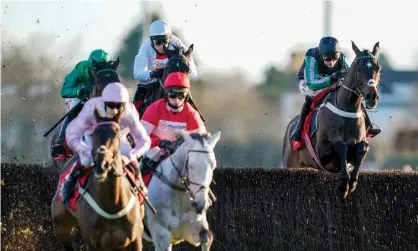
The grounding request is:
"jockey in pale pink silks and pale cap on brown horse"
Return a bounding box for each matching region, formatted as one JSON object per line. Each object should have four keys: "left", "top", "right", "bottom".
{"left": 58, "top": 83, "right": 151, "bottom": 207}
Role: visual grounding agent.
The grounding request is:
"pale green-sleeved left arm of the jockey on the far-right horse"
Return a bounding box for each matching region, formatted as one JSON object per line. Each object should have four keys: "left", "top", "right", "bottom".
{"left": 304, "top": 56, "right": 331, "bottom": 91}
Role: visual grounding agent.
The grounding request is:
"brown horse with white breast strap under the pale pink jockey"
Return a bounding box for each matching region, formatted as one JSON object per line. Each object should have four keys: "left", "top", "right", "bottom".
{"left": 51, "top": 106, "right": 144, "bottom": 251}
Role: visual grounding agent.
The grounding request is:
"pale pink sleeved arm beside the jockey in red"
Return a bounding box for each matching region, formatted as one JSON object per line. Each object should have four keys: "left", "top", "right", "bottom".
{"left": 128, "top": 103, "right": 151, "bottom": 159}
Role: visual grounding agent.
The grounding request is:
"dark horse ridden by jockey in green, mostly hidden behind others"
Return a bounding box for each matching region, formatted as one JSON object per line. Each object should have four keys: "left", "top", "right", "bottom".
{"left": 45, "top": 57, "right": 120, "bottom": 169}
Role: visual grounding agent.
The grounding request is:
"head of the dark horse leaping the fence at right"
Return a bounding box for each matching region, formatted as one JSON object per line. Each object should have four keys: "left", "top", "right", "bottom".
{"left": 351, "top": 41, "right": 381, "bottom": 109}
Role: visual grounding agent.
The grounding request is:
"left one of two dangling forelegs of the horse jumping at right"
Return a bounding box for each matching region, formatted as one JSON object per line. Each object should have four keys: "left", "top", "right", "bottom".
{"left": 334, "top": 141, "right": 350, "bottom": 199}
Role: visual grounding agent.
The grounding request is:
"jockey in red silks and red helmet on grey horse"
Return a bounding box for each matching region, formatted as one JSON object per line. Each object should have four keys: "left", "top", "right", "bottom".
{"left": 141, "top": 72, "right": 207, "bottom": 172}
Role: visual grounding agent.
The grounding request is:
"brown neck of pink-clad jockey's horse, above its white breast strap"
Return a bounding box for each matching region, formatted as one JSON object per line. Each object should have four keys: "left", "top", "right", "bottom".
{"left": 91, "top": 156, "right": 129, "bottom": 208}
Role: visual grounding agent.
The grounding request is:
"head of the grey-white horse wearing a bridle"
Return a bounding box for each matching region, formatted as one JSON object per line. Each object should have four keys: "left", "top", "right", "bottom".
{"left": 174, "top": 131, "right": 221, "bottom": 214}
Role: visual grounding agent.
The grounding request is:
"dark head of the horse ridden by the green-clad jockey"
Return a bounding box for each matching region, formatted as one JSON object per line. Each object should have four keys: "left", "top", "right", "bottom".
{"left": 89, "top": 57, "right": 120, "bottom": 98}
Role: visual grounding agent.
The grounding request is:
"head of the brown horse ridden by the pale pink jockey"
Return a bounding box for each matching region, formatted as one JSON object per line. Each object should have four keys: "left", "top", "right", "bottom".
{"left": 91, "top": 108, "right": 122, "bottom": 180}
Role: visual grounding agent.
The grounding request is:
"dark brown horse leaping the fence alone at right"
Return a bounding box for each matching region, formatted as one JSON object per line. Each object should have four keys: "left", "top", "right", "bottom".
{"left": 283, "top": 42, "right": 381, "bottom": 198}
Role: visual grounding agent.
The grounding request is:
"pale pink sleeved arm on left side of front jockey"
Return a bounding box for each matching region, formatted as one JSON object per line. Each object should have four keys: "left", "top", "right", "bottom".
{"left": 65, "top": 100, "right": 95, "bottom": 154}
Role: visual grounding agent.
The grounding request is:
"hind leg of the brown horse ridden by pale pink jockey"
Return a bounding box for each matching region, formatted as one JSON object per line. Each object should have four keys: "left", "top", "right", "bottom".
{"left": 51, "top": 195, "right": 75, "bottom": 251}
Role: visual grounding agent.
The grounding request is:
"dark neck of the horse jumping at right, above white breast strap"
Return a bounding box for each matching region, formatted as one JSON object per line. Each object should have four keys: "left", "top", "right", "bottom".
{"left": 331, "top": 67, "right": 361, "bottom": 112}
